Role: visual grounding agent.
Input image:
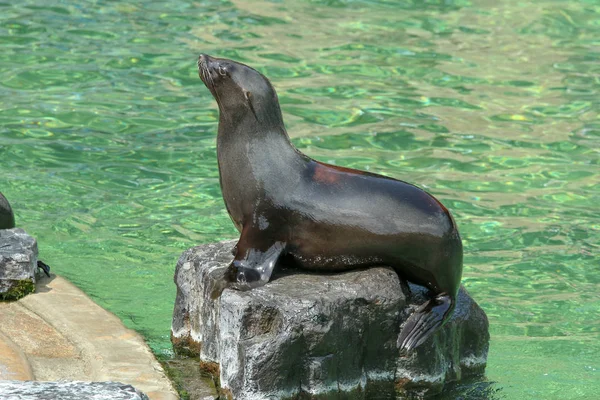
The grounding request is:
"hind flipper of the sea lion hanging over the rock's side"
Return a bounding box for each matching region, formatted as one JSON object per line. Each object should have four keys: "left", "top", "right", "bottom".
{"left": 398, "top": 293, "right": 456, "bottom": 351}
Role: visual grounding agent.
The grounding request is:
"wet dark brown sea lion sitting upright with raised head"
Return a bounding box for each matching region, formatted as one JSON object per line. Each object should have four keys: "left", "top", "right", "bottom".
{"left": 198, "top": 54, "right": 463, "bottom": 351}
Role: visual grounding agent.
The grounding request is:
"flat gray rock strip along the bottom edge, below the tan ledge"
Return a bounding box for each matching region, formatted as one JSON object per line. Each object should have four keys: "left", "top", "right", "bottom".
{"left": 0, "top": 381, "right": 148, "bottom": 400}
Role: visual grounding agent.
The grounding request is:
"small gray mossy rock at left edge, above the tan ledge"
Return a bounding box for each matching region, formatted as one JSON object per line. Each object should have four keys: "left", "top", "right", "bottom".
{"left": 0, "top": 228, "right": 38, "bottom": 300}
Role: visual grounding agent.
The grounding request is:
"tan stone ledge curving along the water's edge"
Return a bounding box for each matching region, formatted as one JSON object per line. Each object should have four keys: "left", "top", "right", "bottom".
{"left": 0, "top": 275, "right": 178, "bottom": 400}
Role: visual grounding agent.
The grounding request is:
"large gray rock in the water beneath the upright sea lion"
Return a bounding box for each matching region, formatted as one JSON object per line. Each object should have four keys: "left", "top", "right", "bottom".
{"left": 171, "top": 241, "right": 489, "bottom": 400}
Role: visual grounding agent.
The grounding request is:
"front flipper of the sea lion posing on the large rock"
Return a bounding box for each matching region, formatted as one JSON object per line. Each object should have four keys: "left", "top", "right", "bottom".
{"left": 225, "top": 240, "right": 285, "bottom": 290}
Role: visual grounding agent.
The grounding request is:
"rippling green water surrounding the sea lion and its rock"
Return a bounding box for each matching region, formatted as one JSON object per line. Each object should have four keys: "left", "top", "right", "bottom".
{"left": 0, "top": 0, "right": 600, "bottom": 400}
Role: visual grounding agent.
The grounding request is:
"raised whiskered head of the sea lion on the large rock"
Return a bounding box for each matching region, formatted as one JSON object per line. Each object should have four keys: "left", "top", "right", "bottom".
{"left": 198, "top": 54, "right": 283, "bottom": 125}
